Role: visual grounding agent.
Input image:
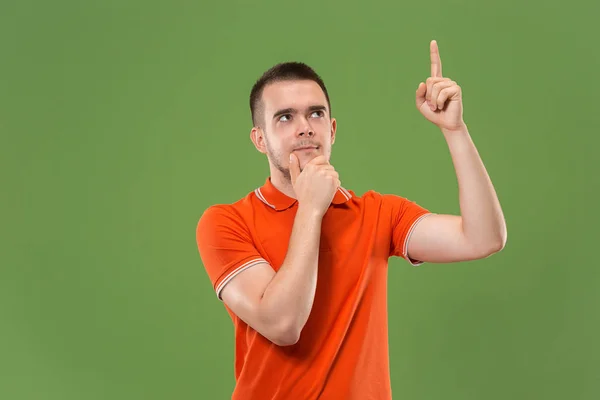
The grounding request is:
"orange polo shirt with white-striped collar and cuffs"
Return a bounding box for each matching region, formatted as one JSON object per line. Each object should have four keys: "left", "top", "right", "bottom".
{"left": 196, "top": 178, "right": 429, "bottom": 400}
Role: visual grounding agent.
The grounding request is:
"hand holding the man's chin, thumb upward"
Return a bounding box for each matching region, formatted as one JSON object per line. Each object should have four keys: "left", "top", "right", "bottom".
{"left": 290, "top": 154, "right": 341, "bottom": 217}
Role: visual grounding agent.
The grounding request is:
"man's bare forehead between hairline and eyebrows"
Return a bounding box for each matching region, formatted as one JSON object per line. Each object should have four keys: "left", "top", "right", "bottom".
{"left": 262, "top": 80, "right": 327, "bottom": 115}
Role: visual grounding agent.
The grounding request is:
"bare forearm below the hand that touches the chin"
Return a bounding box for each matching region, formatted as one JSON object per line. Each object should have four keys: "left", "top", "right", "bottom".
{"left": 260, "top": 206, "right": 323, "bottom": 336}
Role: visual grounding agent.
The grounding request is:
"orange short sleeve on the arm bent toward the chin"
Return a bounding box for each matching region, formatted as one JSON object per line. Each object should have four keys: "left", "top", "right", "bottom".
{"left": 196, "top": 206, "right": 267, "bottom": 300}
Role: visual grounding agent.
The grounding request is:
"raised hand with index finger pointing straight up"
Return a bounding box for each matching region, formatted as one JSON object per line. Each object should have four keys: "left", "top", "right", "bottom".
{"left": 416, "top": 40, "right": 465, "bottom": 131}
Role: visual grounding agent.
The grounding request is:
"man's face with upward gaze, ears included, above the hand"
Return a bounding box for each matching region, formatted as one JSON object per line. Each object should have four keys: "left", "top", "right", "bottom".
{"left": 251, "top": 80, "right": 336, "bottom": 180}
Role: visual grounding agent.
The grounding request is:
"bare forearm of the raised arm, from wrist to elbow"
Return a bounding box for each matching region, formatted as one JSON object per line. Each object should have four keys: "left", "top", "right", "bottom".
{"left": 442, "top": 126, "right": 506, "bottom": 248}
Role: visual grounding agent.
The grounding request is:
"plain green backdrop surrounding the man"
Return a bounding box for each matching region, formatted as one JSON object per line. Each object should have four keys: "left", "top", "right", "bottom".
{"left": 0, "top": 0, "right": 600, "bottom": 400}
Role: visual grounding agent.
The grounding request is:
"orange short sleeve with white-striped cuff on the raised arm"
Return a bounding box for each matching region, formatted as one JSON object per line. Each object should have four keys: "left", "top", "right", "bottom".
{"left": 383, "top": 195, "right": 431, "bottom": 266}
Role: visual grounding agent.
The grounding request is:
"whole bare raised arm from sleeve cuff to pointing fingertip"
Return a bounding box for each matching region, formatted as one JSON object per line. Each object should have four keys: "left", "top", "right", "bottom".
{"left": 408, "top": 41, "right": 507, "bottom": 263}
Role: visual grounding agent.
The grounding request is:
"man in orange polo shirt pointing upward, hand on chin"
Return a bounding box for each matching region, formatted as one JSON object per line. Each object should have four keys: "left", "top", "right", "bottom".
{"left": 196, "top": 41, "right": 506, "bottom": 400}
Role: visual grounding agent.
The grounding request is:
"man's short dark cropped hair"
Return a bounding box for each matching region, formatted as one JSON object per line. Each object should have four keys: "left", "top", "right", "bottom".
{"left": 250, "top": 61, "right": 331, "bottom": 126}
